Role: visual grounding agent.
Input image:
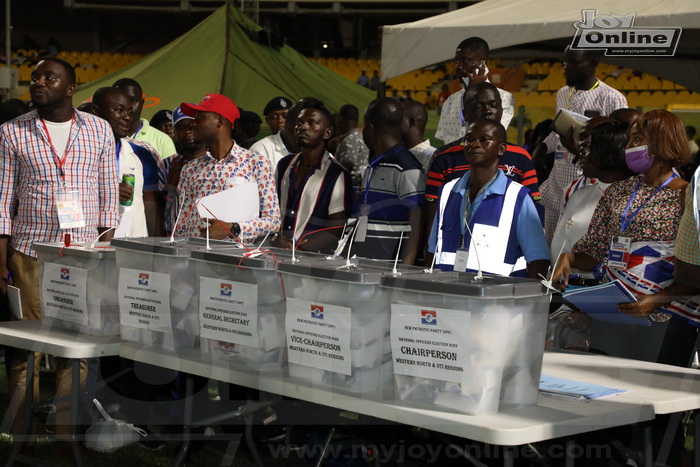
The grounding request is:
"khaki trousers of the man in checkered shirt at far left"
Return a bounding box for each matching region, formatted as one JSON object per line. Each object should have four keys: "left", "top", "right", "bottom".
{"left": 8, "top": 250, "right": 87, "bottom": 437}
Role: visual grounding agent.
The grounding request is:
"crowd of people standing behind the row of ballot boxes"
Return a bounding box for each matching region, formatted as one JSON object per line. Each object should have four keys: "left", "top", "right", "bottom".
{"left": 0, "top": 33, "right": 700, "bottom": 464}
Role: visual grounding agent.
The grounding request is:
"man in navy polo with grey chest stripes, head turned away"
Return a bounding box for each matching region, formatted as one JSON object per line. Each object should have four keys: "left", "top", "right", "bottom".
{"left": 350, "top": 97, "right": 425, "bottom": 264}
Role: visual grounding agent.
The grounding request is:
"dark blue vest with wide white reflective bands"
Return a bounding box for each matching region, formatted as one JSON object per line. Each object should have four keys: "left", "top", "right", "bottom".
{"left": 435, "top": 179, "right": 530, "bottom": 276}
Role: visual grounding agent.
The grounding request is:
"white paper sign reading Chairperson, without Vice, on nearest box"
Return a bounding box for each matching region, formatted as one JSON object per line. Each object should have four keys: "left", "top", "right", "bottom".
{"left": 391, "top": 303, "right": 471, "bottom": 382}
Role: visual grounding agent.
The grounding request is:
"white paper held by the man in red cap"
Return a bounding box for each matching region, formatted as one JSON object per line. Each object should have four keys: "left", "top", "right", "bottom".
{"left": 197, "top": 182, "right": 260, "bottom": 222}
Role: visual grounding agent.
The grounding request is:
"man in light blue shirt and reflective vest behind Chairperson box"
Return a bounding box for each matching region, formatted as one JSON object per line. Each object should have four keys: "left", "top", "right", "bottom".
{"left": 428, "top": 119, "right": 549, "bottom": 278}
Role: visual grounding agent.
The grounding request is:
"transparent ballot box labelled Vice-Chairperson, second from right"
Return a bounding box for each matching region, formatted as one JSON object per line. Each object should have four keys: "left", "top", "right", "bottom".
{"left": 279, "top": 258, "right": 421, "bottom": 397}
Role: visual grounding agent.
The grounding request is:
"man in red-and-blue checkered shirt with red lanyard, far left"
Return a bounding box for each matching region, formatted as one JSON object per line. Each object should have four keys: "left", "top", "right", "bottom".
{"left": 0, "top": 57, "right": 119, "bottom": 435}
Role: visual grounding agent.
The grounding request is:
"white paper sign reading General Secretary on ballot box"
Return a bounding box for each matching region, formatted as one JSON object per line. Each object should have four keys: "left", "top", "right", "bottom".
{"left": 199, "top": 277, "right": 258, "bottom": 348}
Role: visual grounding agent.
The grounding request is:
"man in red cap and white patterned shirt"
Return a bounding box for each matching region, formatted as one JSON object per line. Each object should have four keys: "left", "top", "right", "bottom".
{"left": 175, "top": 94, "right": 280, "bottom": 242}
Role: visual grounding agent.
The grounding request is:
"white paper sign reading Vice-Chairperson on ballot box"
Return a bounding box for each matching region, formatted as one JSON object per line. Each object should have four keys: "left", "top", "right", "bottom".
{"left": 285, "top": 298, "right": 352, "bottom": 375}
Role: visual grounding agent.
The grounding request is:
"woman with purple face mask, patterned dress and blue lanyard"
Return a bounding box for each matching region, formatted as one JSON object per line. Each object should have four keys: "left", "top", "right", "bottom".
{"left": 552, "top": 110, "right": 696, "bottom": 366}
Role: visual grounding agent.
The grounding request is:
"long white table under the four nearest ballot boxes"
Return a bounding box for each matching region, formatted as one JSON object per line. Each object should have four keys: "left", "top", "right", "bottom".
{"left": 120, "top": 342, "right": 654, "bottom": 466}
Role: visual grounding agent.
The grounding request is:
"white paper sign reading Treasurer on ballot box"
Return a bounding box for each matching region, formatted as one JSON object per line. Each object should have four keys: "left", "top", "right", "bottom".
{"left": 118, "top": 268, "right": 173, "bottom": 334}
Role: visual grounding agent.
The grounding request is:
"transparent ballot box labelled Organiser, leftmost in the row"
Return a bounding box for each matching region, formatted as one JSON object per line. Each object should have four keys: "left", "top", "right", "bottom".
{"left": 33, "top": 243, "right": 119, "bottom": 336}
